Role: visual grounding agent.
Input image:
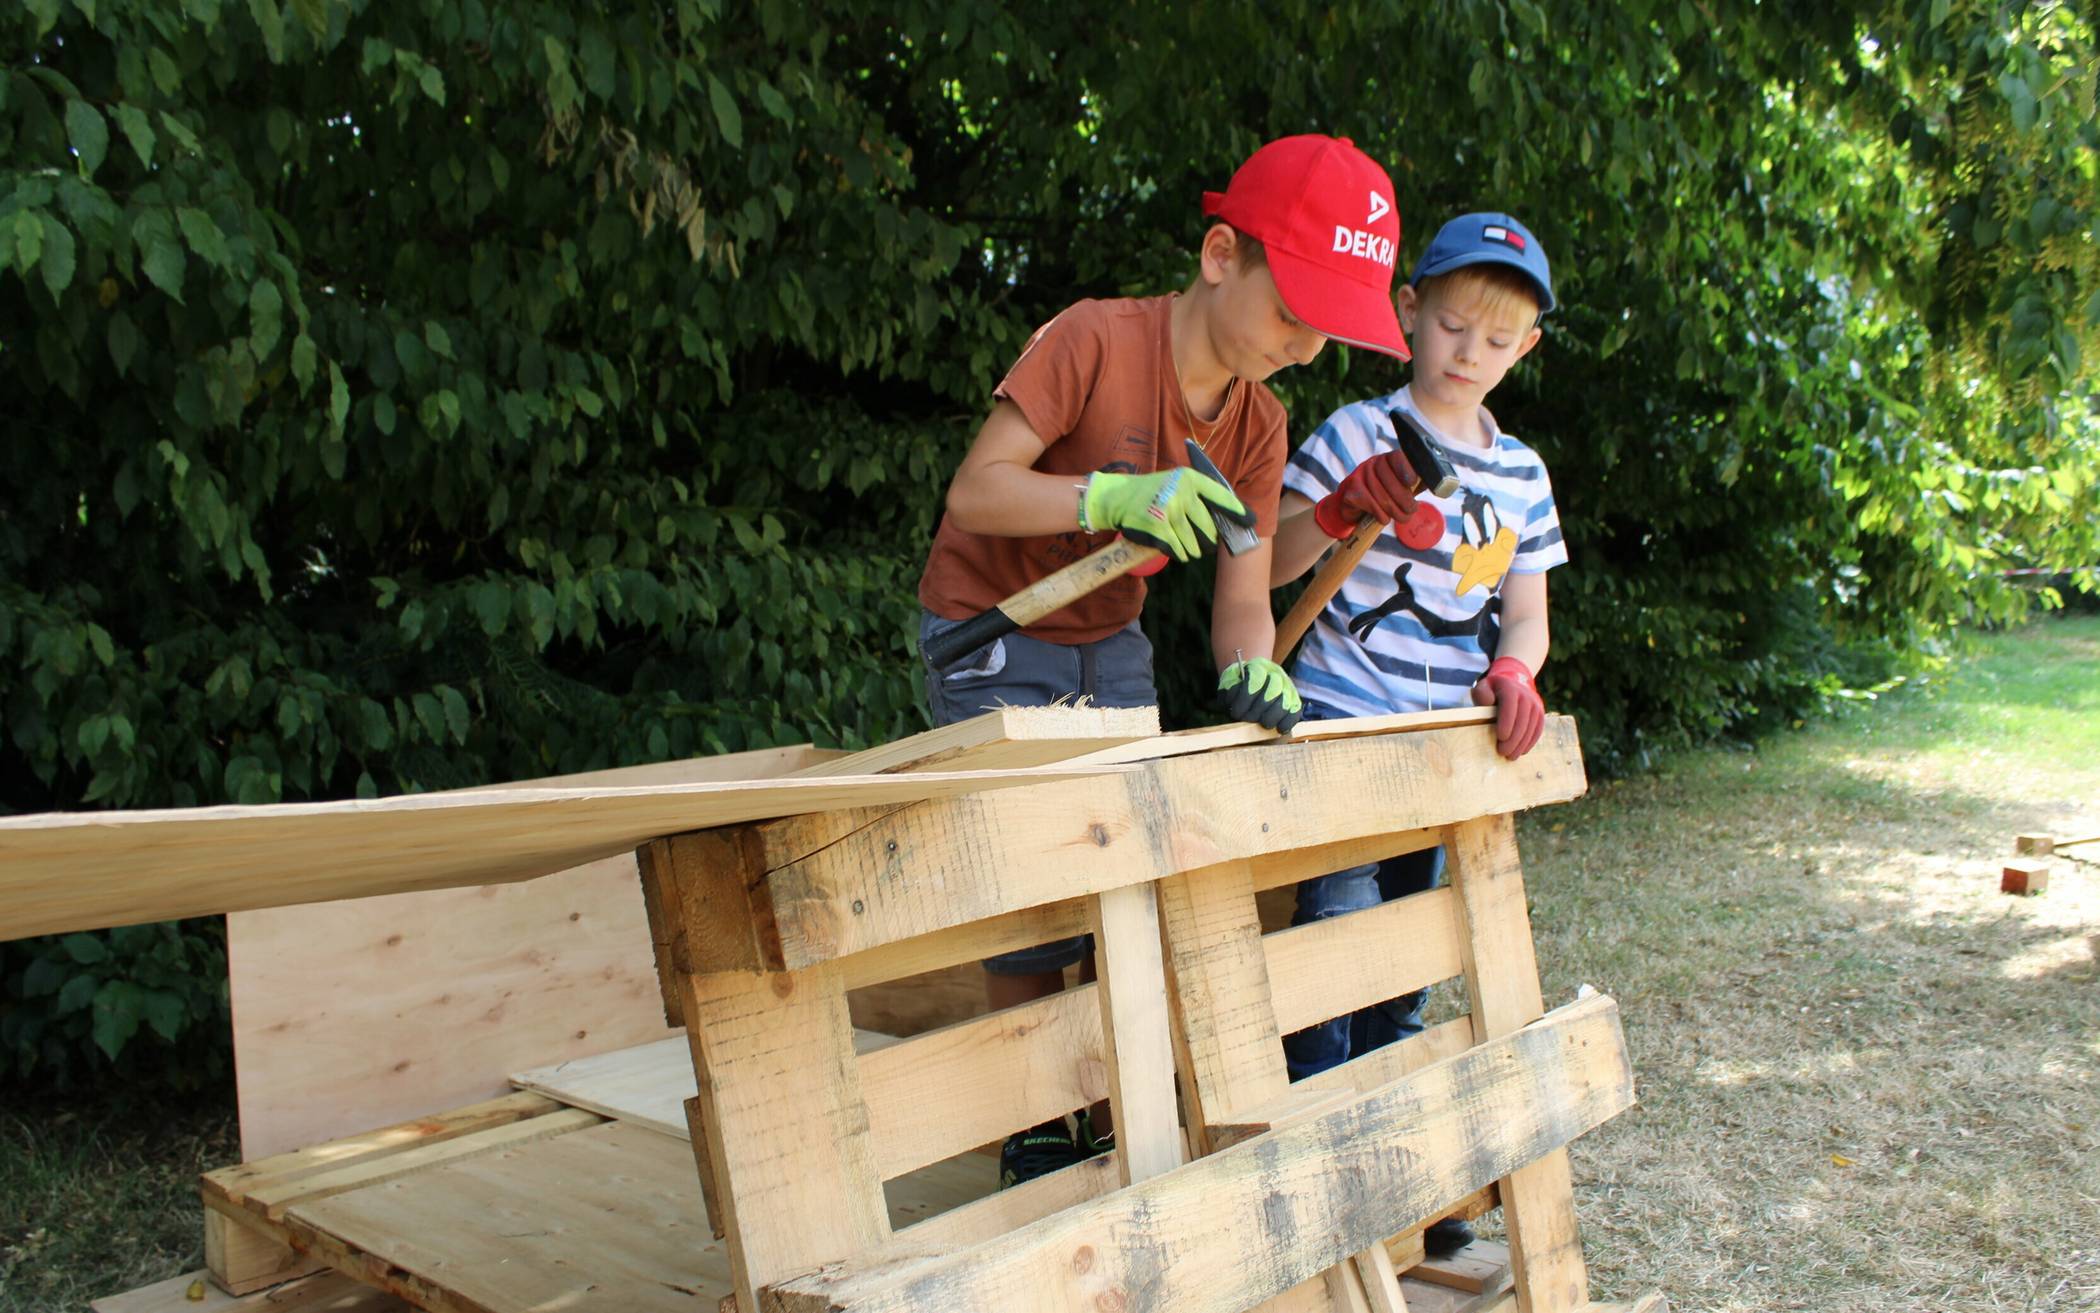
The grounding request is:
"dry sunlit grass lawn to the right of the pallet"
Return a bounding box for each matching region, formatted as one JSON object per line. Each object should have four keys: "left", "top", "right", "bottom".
{"left": 1520, "top": 620, "right": 2100, "bottom": 1313}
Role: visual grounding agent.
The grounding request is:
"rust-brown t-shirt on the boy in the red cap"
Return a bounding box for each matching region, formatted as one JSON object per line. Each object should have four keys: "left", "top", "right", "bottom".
{"left": 920, "top": 296, "right": 1289, "bottom": 643}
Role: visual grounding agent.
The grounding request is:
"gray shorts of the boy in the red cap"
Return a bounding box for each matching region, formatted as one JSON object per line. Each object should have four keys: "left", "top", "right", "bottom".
{"left": 920, "top": 611, "right": 1159, "bottom": 975}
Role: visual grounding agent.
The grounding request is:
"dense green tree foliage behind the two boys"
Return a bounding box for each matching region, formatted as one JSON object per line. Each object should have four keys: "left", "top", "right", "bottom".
{"left": 0, "top": 0, "right": 2100, "bottom": 1063}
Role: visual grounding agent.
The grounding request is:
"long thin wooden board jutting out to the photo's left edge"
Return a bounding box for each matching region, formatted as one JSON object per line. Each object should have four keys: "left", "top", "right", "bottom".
{"left": 0, "top": 752, "right": 1130, "bottom": 937}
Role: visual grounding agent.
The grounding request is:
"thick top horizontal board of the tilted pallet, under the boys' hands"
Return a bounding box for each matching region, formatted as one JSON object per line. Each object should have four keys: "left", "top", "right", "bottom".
{"left": 758, "top": 716, "right": 1583, "bottom": 968}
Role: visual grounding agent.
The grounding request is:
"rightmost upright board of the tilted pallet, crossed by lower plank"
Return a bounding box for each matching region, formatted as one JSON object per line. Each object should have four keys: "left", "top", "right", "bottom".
{"left": 1445, "top": 815, "right": 1590, "bottom": 1313}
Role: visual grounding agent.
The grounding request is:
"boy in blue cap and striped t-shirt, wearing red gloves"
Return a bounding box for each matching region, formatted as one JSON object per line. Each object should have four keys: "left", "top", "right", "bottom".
{"left": 1271, "top": 214, "right": 1567, "bottom": 1252}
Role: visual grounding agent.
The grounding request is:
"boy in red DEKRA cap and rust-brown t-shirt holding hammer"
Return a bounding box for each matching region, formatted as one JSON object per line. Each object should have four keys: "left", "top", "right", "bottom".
{"left": 920, "top": 134, "right": 1407, "bottom": 1185}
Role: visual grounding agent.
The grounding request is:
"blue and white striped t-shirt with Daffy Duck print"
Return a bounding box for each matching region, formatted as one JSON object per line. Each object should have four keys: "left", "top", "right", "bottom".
{"left": 1283, "top": 387, "right": 1569, "bottom": 716}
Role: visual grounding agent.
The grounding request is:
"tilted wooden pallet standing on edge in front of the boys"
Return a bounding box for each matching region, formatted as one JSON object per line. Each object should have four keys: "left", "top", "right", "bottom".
{"left": 641, "top": 718, "right": 1663, "bottom": 1313}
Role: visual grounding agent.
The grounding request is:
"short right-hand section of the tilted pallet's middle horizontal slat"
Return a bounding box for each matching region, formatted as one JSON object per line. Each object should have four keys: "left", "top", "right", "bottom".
{"left": 1262, "top": 889, "right": 1464, "bottom": 1034}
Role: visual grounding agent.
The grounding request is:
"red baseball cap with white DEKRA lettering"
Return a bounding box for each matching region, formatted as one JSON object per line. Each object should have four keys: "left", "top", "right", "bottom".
{"left": 1203, "top": 132, "right": 1411, "bottom": 359}
